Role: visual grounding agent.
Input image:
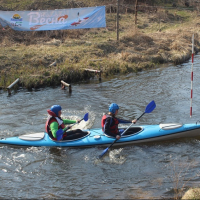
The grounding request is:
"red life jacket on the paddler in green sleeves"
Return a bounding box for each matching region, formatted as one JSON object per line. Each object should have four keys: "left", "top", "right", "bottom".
{"left": 45, "top": 110, "right": 65, "bottom": 140}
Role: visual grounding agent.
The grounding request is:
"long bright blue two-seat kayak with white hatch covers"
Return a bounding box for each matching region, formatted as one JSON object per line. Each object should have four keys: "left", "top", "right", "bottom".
{"left": 0, "top": 123, "right": 200, "bottom": 147}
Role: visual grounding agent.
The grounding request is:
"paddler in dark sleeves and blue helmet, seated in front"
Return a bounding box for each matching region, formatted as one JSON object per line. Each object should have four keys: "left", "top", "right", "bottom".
{"left": 101, "top": 103, "right": 137, "bottom": 140}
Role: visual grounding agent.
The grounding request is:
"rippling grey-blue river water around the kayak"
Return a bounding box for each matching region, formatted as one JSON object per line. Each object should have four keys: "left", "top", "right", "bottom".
{"left": 0, "top": 56, "right": 200, "bottom": 199}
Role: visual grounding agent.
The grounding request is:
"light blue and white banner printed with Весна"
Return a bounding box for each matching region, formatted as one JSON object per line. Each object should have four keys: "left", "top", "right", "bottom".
{"left": 0, "top": 6, "right": 106, "bottom": 31}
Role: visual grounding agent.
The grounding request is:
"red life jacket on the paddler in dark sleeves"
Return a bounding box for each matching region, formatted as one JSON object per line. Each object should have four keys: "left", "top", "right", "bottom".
{"left": 101, "top": 114, "right": 119, "bottom": 134}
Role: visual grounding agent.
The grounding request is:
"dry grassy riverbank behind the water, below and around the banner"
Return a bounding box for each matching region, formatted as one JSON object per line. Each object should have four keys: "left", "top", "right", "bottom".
{"left": 0, "top": 0, "right": 200, "bottom": 89}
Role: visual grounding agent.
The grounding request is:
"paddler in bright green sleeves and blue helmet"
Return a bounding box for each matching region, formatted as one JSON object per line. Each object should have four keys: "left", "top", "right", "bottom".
{"left": 45, "top": 105, "right": 87, "bottom": 140}
